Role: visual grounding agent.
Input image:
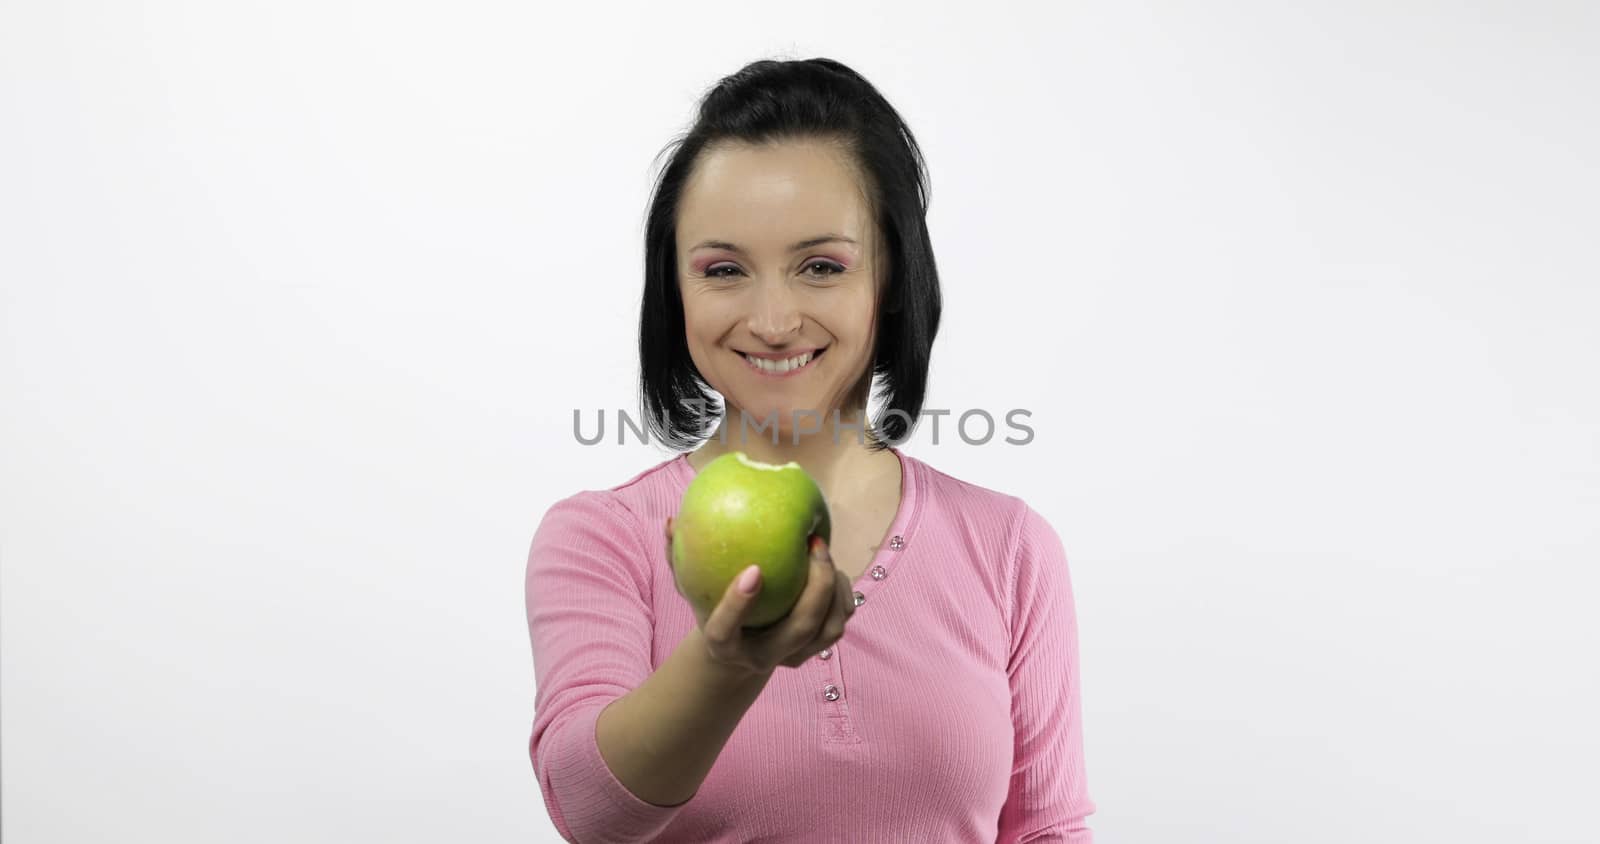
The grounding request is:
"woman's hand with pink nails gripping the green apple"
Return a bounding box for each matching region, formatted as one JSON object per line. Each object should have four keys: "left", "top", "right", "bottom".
{"left": 666, "top": 518, "right": 856, "bottom": 675}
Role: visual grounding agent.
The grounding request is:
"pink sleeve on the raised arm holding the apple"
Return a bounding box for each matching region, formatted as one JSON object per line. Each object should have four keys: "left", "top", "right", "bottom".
{"left": 526, "top": 491, "right": 680, "bottom": 844}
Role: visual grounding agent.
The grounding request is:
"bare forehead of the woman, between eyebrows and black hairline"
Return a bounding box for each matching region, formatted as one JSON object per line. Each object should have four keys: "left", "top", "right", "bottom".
{"left": 678, "top": 141, "right": 870, "bottom": 251}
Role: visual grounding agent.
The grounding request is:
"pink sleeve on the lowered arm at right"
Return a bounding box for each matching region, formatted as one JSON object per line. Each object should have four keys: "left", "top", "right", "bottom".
{"left": 997, "top": 508, "right": 1094, "bottom": 844}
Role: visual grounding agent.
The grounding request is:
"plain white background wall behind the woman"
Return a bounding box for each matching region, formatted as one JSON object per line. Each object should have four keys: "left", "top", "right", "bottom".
{"left": 0, "top": 0, "right": 1600, "bottom": 844}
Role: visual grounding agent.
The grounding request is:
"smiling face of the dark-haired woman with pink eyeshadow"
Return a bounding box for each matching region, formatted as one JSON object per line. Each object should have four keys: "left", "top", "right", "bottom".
{"left": 677, "top": 141, "right": 878, "bottom": 436}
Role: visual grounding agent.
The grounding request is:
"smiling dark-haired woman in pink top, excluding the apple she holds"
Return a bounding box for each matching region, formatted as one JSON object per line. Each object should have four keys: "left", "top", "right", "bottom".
{"left": 526, "top": 59, "right": 1094, "bottom": 842}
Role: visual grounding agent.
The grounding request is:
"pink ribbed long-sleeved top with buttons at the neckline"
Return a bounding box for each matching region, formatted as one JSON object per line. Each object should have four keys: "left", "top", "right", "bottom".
{"left": 526, "top": 449, "right": 1094, "bottom": 844}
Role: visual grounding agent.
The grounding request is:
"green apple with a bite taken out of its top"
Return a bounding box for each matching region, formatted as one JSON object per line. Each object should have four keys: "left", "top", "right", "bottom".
{"left": 672, "top": 451, "right": 832, "bottom": 628}
